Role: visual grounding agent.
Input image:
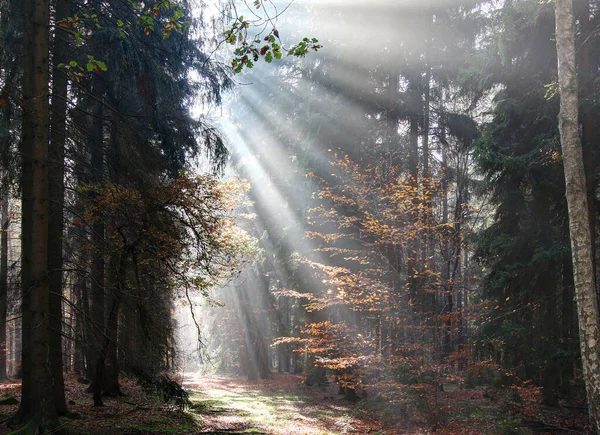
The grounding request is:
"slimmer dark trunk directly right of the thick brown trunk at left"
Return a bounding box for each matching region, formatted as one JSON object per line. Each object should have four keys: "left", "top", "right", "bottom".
{"left": 48, "top": 0, "right": 69, "bottom": 415}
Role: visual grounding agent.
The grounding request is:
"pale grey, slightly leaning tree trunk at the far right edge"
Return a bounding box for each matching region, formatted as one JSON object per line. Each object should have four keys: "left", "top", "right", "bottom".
{"left": 555, "top": 0, "right": 600, "bottom": 432}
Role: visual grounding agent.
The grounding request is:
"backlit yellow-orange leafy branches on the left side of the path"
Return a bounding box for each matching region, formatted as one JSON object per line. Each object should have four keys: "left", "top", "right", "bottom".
{"left": 75, "top": 176, "right": 254, "bottom": 289}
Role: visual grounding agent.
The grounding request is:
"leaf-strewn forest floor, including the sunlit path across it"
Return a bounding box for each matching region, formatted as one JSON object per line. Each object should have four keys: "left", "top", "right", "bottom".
{"left": 0, "top": 374, "right": 586, "bottom": 435}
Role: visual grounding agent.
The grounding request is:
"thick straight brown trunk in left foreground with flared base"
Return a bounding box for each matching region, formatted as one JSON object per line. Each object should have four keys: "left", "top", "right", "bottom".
{"left": 16, "top": 0, "right": 62, "bottom": 433}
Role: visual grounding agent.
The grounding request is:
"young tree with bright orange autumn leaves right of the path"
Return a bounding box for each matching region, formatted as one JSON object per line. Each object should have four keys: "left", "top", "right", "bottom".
{"left": 277, "top": 156, "right": 482, "bottom": 416}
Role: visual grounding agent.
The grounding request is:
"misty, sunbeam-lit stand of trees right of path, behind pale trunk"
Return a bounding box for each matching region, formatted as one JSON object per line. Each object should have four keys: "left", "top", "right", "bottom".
{"left": 199, "top": 1, "right": 598, "bottom": 430}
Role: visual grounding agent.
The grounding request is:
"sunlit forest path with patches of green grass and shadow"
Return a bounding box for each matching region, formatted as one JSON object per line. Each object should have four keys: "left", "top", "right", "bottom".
{"left": 184, "top": 375, "right": 378, "bottom": 435}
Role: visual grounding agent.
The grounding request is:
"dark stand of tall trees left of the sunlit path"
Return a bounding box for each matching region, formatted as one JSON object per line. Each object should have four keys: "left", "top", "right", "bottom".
{"left": 0, "top": 0, "right": 245, "bottom": 433}
